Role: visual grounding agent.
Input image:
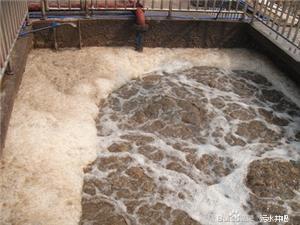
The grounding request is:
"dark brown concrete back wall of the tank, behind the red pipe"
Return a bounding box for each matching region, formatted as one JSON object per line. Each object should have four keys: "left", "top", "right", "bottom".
{"left": 34, "top": 19, "right": 248, "bottom": 48}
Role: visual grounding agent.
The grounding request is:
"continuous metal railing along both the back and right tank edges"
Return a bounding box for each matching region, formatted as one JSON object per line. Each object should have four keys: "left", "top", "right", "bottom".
{"left": 30, "top": 0, "right": 300, "bottom": 53}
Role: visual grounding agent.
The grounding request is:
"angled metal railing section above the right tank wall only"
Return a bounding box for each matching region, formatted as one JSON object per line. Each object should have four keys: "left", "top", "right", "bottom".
{"left": 252, "top": 0, "right": 300, "bottom": 52}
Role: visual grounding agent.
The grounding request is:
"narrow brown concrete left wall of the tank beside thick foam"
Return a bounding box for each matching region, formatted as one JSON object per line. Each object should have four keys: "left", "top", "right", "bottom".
{"left": 0, "top": 28, "right": 33, "bottom": 156}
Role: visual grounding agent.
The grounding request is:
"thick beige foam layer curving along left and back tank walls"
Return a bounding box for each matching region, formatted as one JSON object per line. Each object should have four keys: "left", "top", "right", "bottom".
{"left": 0, "top": 48, "right": 300, "bottom": 225}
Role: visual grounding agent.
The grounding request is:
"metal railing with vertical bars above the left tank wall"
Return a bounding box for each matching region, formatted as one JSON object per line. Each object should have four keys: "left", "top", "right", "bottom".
{"left": 0, "top": 0, "right": 28, "bottom": 80}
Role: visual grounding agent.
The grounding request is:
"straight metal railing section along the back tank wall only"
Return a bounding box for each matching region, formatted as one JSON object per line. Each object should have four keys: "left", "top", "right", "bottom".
{"left": 29, "top": 0, "right": 247, "bottom": 20}
